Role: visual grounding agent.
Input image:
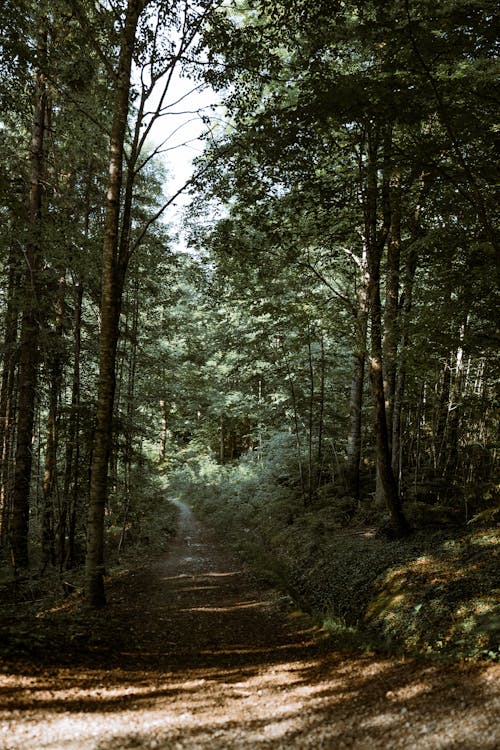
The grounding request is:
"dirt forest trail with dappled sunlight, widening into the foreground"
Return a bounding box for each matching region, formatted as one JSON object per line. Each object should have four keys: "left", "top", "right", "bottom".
{"left": 0, "top": 504, "right": 500, "bottom": 750}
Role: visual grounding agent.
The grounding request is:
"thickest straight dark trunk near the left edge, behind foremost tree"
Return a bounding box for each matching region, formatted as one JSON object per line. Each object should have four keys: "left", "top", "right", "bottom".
{"left": 10, "top": 13, "right": 48, "bottom": 569}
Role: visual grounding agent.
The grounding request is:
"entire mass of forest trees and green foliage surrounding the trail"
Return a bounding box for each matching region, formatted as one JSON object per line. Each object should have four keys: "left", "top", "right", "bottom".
{"left": 0, "top": 0, "right": 500, "bottom": 650}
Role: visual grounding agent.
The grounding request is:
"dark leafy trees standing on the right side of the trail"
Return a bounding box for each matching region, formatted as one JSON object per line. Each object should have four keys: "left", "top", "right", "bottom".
{"left": 188, "top": 0, "right": 498, "bottom": 534}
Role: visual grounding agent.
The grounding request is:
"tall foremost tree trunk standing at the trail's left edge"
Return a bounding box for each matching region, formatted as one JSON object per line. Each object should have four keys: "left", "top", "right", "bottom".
{"left": 85, "top": 0, "right": 145, "bottom": 607}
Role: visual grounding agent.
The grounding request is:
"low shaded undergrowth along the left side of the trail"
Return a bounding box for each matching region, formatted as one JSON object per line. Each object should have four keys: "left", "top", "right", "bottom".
{"left": 0, "top": 473, "right": 179, "bottom": 661}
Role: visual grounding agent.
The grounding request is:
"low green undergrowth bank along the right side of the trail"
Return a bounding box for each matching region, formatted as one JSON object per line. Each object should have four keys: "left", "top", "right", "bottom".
{"left": 170, "top": 446, "right": 500, "bottom": 660}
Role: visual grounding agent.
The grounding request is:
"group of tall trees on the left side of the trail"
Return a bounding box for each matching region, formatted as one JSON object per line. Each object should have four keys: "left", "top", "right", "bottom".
{"left": 0, "top": 0, "right": 223, "bottom": 606}
